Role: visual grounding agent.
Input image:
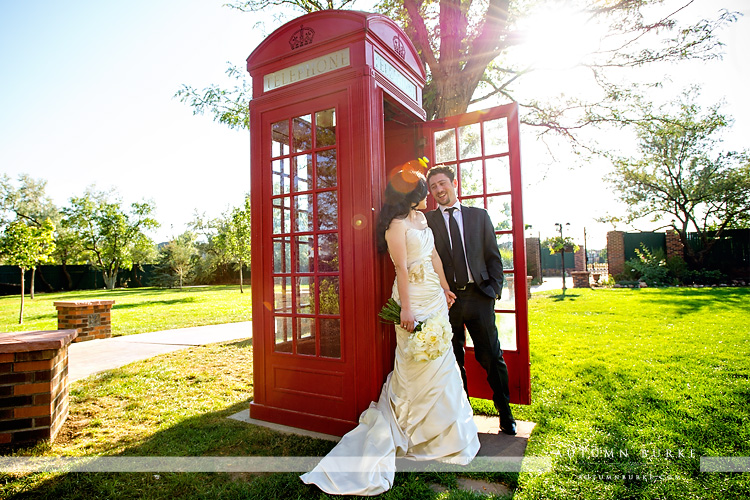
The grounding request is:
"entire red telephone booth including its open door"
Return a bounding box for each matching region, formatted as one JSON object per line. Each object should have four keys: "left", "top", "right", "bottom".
{"left": 247, "top": 10, "right": 529, "bottom": 435}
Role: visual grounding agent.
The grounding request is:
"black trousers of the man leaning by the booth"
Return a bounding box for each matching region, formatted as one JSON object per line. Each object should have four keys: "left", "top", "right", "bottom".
{"left": 448, "top": 283, "right": 513, "bottom": 424}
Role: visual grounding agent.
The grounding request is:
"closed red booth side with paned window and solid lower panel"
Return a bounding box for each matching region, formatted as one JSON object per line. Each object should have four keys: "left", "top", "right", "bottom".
{"left": 262, "top": 92, "right": 354, "bottom": 419}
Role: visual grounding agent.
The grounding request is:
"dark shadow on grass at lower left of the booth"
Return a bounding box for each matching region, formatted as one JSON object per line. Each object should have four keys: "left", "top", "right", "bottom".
{"left": 6, "top": 399, "right": 342, "bottom": 499}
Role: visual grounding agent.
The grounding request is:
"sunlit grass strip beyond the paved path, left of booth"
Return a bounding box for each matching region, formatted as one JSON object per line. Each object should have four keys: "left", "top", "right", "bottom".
{"left": 0, "top": 285, "right": 252, "bottom": 336}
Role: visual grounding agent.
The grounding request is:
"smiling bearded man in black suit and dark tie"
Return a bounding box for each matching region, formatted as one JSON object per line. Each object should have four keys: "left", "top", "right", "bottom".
{"left": 426, "top": 165, "right": 516, "bottom": 435}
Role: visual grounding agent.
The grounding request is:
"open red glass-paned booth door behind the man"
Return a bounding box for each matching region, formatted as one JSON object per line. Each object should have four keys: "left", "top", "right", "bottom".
{"left": 423, "top": 103, "right": 531, "bottom": 404}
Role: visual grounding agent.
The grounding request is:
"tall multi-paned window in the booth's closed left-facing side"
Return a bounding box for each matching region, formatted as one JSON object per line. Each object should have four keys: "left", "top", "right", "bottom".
{"left": 271, "top": 108, "right": 341, "bottom": 358}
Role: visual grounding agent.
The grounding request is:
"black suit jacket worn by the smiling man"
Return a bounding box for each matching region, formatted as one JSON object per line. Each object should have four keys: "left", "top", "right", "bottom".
{"left": 426, "top": 205, "right": 503, "bottom": 298}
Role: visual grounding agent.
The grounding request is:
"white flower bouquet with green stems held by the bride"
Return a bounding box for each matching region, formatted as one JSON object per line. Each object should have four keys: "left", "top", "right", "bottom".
{"left": 378, "top": 298, "right": 453, "bottom": 361}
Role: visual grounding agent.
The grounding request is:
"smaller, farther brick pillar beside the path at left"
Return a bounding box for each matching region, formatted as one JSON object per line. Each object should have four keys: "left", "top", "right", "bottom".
{"left": 54, "top": 300, "right": 115, "bottom": 342}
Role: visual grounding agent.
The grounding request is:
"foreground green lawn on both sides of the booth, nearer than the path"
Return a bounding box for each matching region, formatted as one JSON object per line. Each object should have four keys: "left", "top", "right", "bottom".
{"left": 0, "top": 288, "right": 750, "bottom": 499}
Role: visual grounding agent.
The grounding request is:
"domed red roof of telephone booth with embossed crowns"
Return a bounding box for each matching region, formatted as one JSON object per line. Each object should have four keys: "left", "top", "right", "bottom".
{"left": 247, "top": 10, "right": 426, "bottom": 97}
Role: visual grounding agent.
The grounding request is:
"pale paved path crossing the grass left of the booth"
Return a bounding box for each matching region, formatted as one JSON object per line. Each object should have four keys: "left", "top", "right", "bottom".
{"left": 68, "top": 321, "right": 252, "bottom": 382}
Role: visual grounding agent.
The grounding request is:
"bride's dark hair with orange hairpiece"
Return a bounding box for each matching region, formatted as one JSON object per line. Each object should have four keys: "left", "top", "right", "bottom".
{"left": 375, "top": 170, "right": 428, "bottom": 253}
